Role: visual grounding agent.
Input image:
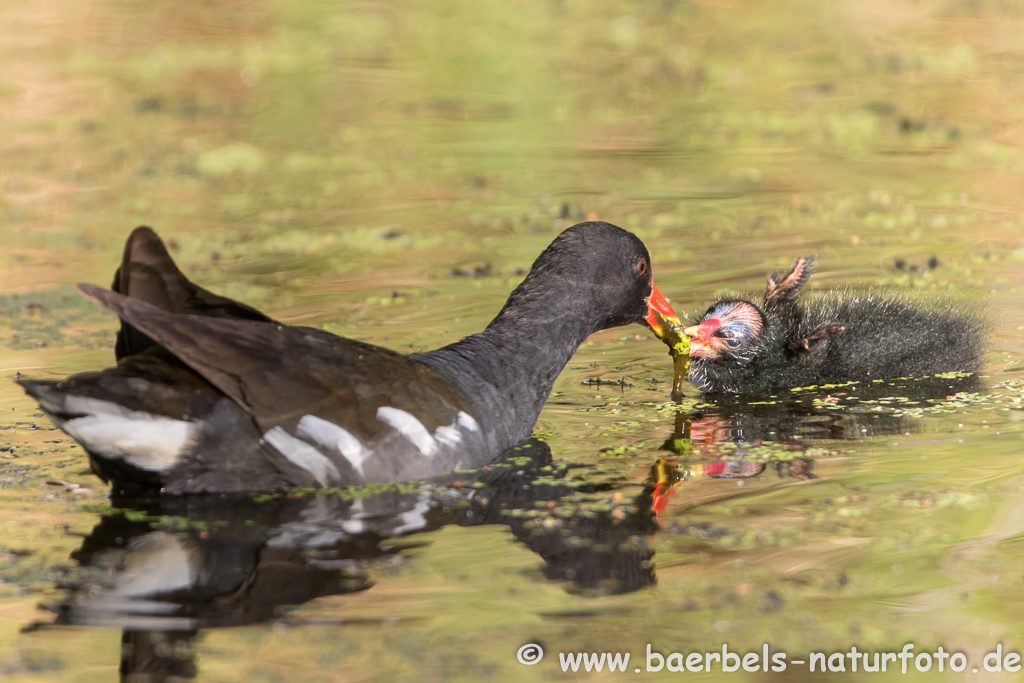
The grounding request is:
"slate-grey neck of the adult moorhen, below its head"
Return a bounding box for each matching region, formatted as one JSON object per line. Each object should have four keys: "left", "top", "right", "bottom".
{"left": 412, "top": 306, "right": 597, "bottom": 454}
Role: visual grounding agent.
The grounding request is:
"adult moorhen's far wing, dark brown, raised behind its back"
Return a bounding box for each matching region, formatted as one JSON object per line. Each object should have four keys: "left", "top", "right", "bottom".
{"left": 111, "top": 225, "right": 272, "bottom": 360}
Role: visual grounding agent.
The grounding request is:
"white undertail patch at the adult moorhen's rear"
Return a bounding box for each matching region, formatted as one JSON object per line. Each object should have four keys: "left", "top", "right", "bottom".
{"left": 59, "top": 396, "right": 199, "bottom": 472}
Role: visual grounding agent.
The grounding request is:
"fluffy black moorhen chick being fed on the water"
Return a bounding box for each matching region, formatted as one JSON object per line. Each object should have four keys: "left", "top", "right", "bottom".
{"left": 686, "top": 256, "right": 986, "bottom": 393}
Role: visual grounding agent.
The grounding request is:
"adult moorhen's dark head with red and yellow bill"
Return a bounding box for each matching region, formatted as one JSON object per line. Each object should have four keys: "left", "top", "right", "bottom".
{"left": 496, "top": 221, "right": 679, "bottom": 336}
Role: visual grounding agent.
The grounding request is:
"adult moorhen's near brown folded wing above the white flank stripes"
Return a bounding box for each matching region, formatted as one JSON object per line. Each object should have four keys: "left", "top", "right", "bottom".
{"left": 78, "top": 284, "right": 468, "bottom": 439}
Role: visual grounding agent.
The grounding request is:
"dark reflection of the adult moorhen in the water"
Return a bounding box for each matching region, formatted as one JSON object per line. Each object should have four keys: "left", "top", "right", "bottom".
{"left": 29, "top": 438, "right": 658, "bottom": 655}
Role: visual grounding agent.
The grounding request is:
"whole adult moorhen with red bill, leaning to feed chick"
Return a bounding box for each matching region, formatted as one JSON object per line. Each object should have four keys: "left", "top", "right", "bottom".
{"left": 22, "top": 222, "right": 678, "bottom": 493}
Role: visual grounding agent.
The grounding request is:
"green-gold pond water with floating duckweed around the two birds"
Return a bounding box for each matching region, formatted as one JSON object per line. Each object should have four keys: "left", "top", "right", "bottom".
{"left": 0, "top": 0, "right": 1024, "bottom": 682}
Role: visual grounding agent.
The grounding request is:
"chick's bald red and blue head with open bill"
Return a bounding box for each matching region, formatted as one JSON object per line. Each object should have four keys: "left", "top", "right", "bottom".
{"left": 685, "top": 299, "right": 768, "bottom": 364}
